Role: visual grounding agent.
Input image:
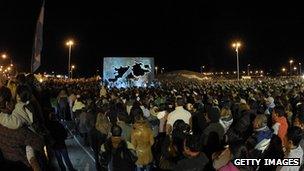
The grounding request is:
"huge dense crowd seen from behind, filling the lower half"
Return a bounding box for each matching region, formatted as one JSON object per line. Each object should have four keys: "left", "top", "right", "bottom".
{"left": 0, "top": 74, "right": 304, "bottom": 171}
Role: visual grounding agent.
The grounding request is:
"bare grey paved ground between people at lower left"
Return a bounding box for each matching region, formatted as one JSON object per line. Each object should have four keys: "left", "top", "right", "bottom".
{"left": 52, "top": 123, "right": 96, "bottom": 171}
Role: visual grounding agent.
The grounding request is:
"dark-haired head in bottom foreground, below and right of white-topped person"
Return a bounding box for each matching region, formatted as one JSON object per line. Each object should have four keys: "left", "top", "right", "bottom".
{"left": 184, "top": 135, "right": 201, "bottom": 156}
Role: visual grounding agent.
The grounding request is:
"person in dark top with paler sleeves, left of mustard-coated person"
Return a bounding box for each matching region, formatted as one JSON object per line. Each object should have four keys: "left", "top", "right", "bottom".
{"left": 100, "top": 125, "right": 138, "bottom": 171}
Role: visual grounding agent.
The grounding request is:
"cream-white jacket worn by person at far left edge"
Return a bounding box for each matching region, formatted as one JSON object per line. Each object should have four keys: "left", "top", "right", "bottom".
{"left": 0, "top": 102, "right": 33, "bottom": 129}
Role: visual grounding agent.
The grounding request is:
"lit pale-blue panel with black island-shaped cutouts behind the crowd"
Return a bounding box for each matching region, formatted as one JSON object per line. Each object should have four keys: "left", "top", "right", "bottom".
{"left": 103, "top": 57, "right": 154, "bottom": 88}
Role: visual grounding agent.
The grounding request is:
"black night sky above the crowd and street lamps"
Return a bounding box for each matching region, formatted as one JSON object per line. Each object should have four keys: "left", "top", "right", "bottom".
{"left": 0, "top": 0, "right": 304, "bottom": 76}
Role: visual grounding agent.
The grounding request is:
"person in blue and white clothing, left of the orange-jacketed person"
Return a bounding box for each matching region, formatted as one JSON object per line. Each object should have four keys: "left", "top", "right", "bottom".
{"left": 245, "top": 114, "right": 273, "bottom": 157}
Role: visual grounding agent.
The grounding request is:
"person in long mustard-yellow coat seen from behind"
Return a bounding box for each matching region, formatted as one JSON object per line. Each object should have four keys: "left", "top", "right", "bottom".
{"left": 131, "top": 113, "right": 154, "bottom": 171}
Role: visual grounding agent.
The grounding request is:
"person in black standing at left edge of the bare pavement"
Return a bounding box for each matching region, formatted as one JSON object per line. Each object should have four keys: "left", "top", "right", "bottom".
{"left": 48, "top": 114, "right": 75, "bottom": 171}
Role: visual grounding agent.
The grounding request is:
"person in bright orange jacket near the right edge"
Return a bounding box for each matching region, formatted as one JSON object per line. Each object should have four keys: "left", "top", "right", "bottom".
{"left": 272, "top": 106, "right": 288, "bottom": 144}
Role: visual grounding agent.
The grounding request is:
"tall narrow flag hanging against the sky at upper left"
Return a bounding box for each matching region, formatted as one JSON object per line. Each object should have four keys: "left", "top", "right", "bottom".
{"left": 31, "top": 1, "right": 44, "bottom": 73}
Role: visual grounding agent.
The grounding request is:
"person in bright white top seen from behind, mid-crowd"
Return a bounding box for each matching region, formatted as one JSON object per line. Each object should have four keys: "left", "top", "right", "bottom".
{"left": 166, "top": 97, "right": 191, "bottom": 134}
